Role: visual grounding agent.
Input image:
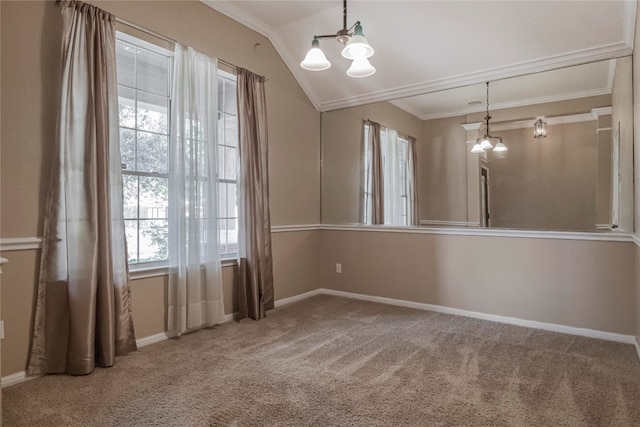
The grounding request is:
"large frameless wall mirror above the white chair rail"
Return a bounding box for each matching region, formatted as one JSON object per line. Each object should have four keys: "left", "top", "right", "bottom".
{"left": 322, "top": 57, "right": 633, "bottom": 232}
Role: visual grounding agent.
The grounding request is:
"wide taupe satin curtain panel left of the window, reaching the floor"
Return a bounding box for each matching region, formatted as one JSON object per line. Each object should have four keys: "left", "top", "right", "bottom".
{"left": 28, "top": 1, "right": 136, "bottom": 375}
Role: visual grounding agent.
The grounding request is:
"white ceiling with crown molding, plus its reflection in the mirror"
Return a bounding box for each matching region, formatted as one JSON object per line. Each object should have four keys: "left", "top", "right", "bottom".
{"left": 201, "top": 0, "right": 636, "bottom": 113}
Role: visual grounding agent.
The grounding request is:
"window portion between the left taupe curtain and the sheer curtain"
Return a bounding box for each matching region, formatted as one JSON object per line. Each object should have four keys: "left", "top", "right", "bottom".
{"left": 116, "top": 33, "right": 173, "bottom": 264}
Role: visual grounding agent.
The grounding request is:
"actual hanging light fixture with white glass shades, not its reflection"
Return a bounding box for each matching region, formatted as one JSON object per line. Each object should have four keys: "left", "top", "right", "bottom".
{"left": 300, "top": 0, "right": 376, "bottom": 78}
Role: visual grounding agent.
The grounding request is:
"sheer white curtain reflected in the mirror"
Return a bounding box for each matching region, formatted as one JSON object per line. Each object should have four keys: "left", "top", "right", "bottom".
{"left": 382, "top": 129, "right": 406, "bottom": 225}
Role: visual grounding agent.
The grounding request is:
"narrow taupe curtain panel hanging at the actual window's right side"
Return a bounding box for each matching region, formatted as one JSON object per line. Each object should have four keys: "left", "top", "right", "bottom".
{"left": 237, "top": 68, "right": 273, "bottom": 320}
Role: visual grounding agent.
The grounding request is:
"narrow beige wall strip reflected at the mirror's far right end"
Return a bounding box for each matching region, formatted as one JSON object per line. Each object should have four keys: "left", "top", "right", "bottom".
{"left": 611, "top": 57, "right": 634, "bottom": 233}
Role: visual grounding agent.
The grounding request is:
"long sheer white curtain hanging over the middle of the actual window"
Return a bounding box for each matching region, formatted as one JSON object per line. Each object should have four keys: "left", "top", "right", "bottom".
{"left": 168, "top": 44, "right": 224, "bottom": 333}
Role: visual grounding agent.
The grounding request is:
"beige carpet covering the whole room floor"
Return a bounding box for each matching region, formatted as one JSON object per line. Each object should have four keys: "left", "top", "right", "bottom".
{"left": 3, "top": 296, "right": 640, "bottom": 427}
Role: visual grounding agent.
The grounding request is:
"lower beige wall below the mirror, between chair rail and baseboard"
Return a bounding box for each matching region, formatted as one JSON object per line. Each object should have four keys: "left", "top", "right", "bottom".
{"left": 321, "top": 231, "right": 635, "bottom": 334}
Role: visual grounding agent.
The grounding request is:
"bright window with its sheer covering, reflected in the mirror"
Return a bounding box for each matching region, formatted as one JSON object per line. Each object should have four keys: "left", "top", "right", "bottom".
{"left": 363, "top": 123, "right": 411, "bottom": 225}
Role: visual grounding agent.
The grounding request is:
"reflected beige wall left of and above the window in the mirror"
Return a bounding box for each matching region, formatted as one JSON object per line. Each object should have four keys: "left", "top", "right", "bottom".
{"left": 322, "top": 102, "right": 422, "bottom": 224}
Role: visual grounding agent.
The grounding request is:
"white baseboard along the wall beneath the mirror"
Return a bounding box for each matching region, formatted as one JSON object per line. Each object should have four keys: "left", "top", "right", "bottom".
{"left": 320, "top": 289, "right": 640, "bottom": 351}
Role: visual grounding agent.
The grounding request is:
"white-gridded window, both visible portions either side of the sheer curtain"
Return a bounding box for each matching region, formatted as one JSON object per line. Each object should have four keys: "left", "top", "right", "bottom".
{"left": 116, "top": 33, "right": 239, "bottom": 266}
